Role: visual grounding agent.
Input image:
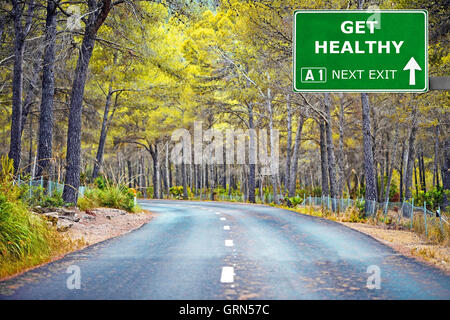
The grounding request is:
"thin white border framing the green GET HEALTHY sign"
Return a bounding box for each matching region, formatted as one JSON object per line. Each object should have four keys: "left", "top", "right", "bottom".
{"left": 292, "top": 9, "right": 429, "bottom": 92}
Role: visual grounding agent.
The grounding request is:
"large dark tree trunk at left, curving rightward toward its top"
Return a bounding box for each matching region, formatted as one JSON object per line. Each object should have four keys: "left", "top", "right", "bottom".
{"left": 63, "top": 0, "right": 111, "bottom": 204}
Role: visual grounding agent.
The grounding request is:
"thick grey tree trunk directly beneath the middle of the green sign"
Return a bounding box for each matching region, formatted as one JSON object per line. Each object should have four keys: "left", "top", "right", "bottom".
{"left": 361, "top": 93, "right": 377, "bottom": 213}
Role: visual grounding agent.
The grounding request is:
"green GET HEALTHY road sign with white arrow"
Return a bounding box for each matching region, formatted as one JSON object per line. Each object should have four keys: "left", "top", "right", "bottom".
{"left": 293, "top": 10, "right": 428, "bottom": 92}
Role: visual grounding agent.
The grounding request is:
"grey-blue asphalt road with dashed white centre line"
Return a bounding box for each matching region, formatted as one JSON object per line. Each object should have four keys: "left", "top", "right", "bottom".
{"left": 0, "top": 200, "right": 450, "bottom": 299}
